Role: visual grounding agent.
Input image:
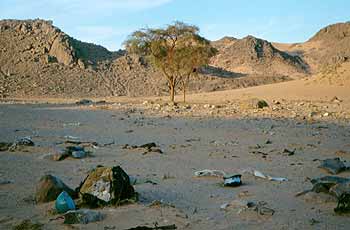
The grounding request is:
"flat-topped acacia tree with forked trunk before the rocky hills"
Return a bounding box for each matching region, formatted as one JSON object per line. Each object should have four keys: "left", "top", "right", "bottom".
{"left": 124, "top": 22, "right": 216, "bottom": 102}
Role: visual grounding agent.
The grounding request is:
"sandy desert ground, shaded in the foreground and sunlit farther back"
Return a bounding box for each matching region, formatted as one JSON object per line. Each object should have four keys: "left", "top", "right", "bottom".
{"left": 0, "top": 81, "right": 350, "bottom": 229}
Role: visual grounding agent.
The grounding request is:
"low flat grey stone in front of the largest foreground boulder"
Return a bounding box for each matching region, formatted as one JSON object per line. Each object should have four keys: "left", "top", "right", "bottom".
{"left": 64, "top": 209, "right": 104, "bottom": 224}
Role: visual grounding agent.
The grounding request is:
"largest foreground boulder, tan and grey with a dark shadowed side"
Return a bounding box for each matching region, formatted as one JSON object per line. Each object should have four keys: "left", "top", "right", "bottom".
{"left": 78, "top": 166, "right": 135, "bottom": 208}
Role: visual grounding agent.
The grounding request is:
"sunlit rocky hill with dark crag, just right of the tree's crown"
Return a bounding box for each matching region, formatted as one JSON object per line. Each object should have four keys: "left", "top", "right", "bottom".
{"left": 212, "top": 36, "right": 308, "bottom": 76}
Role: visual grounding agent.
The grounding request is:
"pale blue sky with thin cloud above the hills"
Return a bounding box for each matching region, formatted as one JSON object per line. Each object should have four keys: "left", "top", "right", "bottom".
{"left": 0, "top": 0, "right": 350, "bottom": 50}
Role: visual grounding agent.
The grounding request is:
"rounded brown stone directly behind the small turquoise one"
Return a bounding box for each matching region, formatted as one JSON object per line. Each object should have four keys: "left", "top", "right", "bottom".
{"left": 35, "top": 175, "right": 77, "bottom": 203}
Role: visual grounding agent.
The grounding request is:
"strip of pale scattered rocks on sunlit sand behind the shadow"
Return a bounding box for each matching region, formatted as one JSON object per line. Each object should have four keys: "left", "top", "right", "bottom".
{"left": 102, "top": 97, "right": 350, "bottom": 121}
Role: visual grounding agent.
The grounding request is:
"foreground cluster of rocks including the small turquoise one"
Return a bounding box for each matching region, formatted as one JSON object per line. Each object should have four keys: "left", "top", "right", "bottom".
{"left": 35, "top": 166, "right": 137, "bottom": 224}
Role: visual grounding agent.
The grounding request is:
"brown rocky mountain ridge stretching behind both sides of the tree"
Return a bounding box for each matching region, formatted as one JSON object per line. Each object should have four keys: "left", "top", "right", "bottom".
{"left": 0, "top": 19, "right": 350, "bottom": 98}
